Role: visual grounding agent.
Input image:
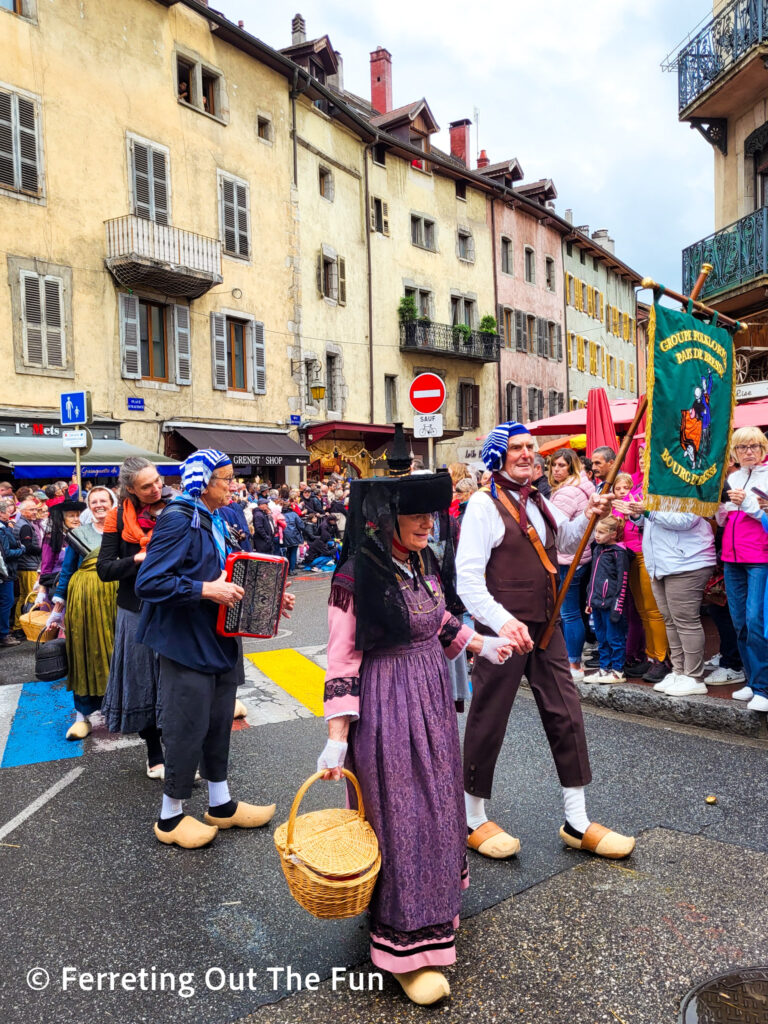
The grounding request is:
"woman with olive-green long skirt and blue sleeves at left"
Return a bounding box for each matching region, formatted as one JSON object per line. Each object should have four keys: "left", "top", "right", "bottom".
{"left": 47, "top": 487, "right": 118, "bottom": 739}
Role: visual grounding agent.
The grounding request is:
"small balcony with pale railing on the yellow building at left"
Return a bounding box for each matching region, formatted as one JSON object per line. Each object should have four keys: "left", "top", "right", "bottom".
{"left": 104, "top": 215, "right": 223, "bottom": 299}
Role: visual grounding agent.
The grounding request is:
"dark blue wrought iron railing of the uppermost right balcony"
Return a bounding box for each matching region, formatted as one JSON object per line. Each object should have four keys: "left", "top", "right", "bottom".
{"left": 677, "top": 0, "right": 768, "bottom": 111}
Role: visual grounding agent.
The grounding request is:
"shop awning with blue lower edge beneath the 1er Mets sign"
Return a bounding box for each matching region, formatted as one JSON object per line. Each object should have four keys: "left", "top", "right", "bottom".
{"left": 0, "top": 437, "right": 179, "bottom": 480}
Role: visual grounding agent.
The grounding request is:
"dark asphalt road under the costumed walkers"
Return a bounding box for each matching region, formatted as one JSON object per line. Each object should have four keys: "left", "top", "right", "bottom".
{"left": 0, "top": 580, "right": 768, "bottom": 1024}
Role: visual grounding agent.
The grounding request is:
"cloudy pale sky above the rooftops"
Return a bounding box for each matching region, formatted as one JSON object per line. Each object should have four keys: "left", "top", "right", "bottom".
{"left": 211, "top": 0, "right": 714, "bottom": 298}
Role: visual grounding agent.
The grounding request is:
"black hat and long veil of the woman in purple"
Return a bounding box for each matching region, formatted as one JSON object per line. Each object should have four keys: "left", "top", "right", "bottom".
{"left": 331, "top": 473, "right": 453, "bottom": 650}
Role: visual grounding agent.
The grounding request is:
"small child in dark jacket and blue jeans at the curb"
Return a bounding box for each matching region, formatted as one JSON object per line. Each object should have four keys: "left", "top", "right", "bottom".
{"left": 584, "top": 516, "right": 632, "bottom": 684}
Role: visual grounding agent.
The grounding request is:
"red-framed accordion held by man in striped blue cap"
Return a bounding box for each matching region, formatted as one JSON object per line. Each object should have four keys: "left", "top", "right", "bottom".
{"left": 216, "top": 551, "right": 288, "bottom": 638}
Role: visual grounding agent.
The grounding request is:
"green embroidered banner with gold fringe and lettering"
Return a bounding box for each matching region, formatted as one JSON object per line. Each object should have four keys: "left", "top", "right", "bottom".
{"left": 644, "top": 303, "right": 735, "bottom": 516}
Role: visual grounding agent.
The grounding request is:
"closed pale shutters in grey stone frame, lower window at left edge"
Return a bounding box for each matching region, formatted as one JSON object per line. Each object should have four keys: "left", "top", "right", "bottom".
{"left": 20, "top": 270, "right": 67, "bottom": 370}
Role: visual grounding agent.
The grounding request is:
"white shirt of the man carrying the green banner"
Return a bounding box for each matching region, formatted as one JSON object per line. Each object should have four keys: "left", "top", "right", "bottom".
{"left": 456, "top": 477, "right": 589, "bottom": 634}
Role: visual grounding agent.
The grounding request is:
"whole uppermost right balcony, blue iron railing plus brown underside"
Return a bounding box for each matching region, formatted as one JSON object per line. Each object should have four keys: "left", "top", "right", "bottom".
{"left": 663, "top": 0, "right": 768, "bottom": 120}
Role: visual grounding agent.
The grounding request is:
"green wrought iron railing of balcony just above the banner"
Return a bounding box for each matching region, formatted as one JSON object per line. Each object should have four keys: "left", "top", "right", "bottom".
{"left": 683, "top": 206, "right": 768, "bottom": 298}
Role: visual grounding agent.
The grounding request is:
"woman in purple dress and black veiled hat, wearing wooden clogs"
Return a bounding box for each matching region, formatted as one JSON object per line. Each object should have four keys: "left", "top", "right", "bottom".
{"left": 317, "top": 473, "right": 510, "bottom": 1005}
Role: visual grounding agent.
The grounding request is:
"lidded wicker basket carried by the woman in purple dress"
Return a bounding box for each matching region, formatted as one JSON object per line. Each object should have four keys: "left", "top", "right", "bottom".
{"left": 274, "top": 769, "right": 381, "bottom": 918}
